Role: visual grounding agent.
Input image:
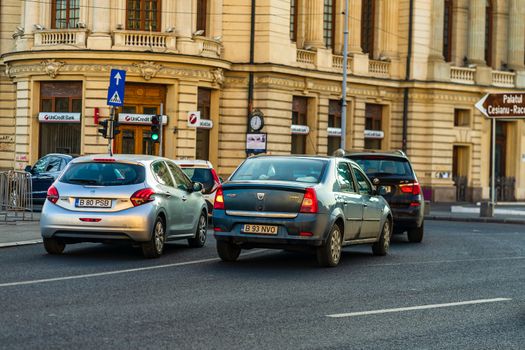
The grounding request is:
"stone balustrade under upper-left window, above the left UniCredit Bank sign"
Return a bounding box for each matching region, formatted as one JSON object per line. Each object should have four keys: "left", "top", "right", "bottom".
{"left": 34, "top": 29, "right": 87, "bottom": 50}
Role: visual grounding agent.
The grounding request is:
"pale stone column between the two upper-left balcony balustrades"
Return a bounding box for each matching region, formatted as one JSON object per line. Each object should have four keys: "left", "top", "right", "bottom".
{"left": 87, "top": 0, "right": 111, "bottom": 50}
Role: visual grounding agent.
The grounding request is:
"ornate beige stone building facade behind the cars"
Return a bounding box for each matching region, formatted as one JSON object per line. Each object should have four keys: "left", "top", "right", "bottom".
{"left": 0, "top": 0, "right": 525, "bottom": 201}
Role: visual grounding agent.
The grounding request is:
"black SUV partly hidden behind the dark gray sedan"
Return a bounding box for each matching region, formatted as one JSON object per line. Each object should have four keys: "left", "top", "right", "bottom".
{"left": 344, "top": 151, "right": 425, "bottom": 243}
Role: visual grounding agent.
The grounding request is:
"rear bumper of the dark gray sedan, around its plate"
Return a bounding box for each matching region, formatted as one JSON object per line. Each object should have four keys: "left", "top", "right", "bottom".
{"left": 213, "top": 210, "right": 330, "bottom": 248}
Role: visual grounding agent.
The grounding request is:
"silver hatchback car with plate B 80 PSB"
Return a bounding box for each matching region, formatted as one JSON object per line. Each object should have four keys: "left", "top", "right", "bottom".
{"left": 40, "top": 154, "right": 208, "bottom": 258}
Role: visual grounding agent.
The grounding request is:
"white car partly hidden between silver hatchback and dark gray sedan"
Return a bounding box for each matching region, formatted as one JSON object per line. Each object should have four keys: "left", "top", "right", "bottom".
{"left": 175, "top": 159, "right": 222, "bottom": 214}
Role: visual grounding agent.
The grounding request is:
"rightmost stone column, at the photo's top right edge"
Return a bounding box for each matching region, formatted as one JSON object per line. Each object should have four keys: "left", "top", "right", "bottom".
{"left": 507, "top": 0, "right": 525, "bottom": 70}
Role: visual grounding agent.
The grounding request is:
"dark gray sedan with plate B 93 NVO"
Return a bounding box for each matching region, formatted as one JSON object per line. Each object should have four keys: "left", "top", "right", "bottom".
{"left": 213, "top": 156, "right": 392, "bottom": 266}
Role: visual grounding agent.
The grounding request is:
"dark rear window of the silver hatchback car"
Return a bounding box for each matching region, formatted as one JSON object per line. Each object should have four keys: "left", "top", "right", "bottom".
{"left": 59, "top": 162, "right": 146, "bottom": 186}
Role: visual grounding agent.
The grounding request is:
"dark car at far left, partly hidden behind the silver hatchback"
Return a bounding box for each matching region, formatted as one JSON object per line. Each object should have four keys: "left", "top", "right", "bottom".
{"left": 25, "top": 153, "right": 73, "bottom": 204}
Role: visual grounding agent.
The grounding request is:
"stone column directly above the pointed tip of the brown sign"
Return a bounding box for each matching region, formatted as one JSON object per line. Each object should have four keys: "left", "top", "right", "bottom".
{"left": 468, "top": 0, "right": 487, "bottom": 65}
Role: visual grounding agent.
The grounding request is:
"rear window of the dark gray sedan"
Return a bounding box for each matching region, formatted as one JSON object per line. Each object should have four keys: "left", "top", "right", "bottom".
{"left": 230, "top": 157, "right": 328, "bottom": 183}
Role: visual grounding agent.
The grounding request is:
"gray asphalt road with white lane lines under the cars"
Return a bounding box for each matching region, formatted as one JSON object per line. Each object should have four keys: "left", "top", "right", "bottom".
{"left": 0, "top": 221, "right": 525, "bottom": 349}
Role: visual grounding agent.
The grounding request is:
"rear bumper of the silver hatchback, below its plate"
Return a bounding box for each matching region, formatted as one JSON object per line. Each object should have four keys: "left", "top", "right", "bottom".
{"left": 40, "top": 201, "right": 156, "bottom": 242}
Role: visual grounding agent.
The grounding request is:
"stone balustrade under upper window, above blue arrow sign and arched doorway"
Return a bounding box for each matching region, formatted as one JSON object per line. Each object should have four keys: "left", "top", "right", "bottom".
{"left": 113, "top": 30, "right": 176, "bottom": 52}
